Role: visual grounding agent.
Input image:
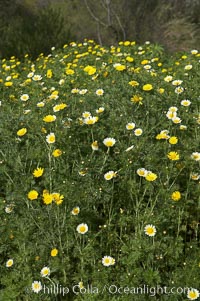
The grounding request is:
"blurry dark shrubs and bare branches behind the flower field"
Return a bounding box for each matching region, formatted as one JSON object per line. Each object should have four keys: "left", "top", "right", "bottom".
{"left": 0, "top": 0, "right": 200, "bottom": 58}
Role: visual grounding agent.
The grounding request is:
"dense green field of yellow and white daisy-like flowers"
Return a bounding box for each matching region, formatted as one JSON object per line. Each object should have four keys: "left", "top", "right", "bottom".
{"left": 0, "top": 40, "right": 200, "bottom": 301}
